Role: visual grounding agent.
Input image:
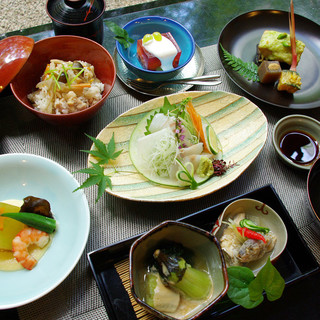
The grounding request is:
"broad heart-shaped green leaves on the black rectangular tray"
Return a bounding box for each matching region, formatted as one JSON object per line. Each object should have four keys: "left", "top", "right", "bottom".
{"left": 227, "top": 258, "right": 285, "bottom": 309}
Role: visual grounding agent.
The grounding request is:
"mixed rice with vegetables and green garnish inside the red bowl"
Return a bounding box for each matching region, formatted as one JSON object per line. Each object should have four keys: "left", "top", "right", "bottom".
{"left": 28, "top": 59, "right": 104, "bottom": 114}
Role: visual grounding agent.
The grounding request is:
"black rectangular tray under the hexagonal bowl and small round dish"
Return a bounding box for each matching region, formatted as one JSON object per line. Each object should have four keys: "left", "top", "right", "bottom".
{"left": 88, "top": 185, "right": 320, "bottom": 320}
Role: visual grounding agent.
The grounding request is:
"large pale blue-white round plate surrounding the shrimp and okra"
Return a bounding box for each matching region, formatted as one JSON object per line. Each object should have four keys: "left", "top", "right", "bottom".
{"left": 0, "top": 153, "right": 90, "bottom": 309}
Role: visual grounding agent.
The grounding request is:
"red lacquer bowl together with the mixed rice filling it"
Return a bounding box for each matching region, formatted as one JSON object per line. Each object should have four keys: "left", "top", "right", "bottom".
{"left": 10, "top": 36, "right": 116, "bottom": 125}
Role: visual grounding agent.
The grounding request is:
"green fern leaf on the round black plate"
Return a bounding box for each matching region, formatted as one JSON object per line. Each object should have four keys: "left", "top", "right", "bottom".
{"left": 220, "top": 43, "right": 259, "bottom": 82}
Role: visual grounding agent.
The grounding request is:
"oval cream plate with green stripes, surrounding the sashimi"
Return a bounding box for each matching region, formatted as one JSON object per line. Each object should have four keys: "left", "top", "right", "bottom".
{"left": 88, "top": 91, "right": 267, "bottom": 202}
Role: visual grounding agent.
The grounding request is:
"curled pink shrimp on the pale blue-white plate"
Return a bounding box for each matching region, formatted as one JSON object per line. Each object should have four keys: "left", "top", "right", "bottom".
{"left": 12, "top": 228, "right": 50, "bottom": 270}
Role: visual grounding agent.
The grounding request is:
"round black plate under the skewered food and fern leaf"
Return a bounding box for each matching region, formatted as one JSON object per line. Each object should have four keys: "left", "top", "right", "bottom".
{"left": 219, "top": 10, "right": 320, "bottom": 109}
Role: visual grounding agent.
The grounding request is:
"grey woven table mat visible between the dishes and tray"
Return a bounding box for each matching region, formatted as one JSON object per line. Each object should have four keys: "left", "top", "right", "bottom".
{"left": 0, "top": 45, "right": 320, "bottom": 320}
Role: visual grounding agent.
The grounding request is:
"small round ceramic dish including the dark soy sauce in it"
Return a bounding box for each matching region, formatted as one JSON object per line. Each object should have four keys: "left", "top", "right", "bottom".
{"left": 272, "top": 114, "right": 320, "bottom": 170}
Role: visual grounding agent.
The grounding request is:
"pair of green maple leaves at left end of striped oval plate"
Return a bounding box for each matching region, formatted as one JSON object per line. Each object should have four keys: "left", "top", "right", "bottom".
{"left": 73, "top": 133, "right": 123, "bottom": 202}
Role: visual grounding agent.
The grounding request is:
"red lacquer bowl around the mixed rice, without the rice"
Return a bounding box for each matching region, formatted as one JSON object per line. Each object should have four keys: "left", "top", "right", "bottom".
{"left": 10, "top": 36, "right": 116, "bottom": 125}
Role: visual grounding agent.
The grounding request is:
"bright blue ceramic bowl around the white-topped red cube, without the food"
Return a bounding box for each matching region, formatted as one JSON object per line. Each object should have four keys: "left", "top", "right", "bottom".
{"left": 116, "top": 16, "right": 195, "bottom": 81}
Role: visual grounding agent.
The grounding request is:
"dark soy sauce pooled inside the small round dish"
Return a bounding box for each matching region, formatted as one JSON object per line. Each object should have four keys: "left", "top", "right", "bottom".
{"left": 280, "top": 130, "right": 319, "bottom": 164}
